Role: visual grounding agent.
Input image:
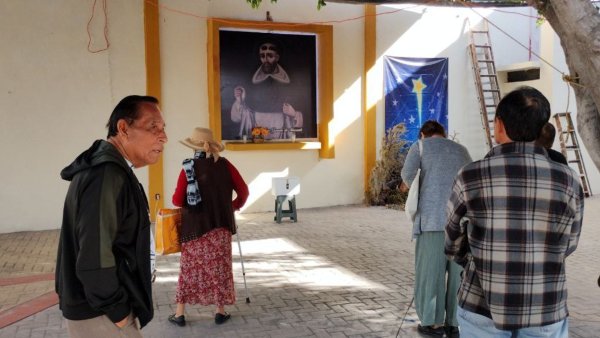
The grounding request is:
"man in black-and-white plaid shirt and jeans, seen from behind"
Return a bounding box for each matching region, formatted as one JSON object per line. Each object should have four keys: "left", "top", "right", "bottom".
{"left": 445, "top": 87, "right": 584, "bottom": 338}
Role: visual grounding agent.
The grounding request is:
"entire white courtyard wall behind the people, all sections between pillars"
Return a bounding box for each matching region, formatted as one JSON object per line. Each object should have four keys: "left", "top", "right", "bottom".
{"left": 0, "top": 0, "right": 600, "bottom": 232}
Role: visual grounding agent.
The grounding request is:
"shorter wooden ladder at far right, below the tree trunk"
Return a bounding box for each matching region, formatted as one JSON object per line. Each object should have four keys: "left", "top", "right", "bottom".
{"left": 554, "top": 112, "right": 592, "bottom": 197}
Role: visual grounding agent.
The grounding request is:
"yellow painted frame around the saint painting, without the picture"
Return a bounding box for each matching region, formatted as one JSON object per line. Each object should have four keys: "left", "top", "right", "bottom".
{"left": 207, "top": 18, "right": 335, "bottom": 158}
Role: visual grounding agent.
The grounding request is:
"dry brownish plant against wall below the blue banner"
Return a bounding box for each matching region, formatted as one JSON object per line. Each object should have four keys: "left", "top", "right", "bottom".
{"left": 365, "top": 123, "right": 407, "bottom": 208}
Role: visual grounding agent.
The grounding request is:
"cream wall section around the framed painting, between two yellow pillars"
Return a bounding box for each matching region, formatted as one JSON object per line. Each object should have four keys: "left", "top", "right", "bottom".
{"left": 160, "top": 0, "right": 364, "bottom": 212}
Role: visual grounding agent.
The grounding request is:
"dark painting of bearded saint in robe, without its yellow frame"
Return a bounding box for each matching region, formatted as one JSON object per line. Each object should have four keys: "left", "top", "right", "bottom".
{"left": 219, "top": 28, "right": 318, "bottom": 140}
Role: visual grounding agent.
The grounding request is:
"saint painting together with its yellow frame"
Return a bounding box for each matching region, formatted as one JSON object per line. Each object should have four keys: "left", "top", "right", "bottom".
{"left": 208, "top": 19, "right": 333, "bottom": 157}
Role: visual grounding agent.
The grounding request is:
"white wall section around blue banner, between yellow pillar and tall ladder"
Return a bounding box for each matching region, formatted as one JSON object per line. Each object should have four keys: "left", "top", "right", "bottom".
{"left": 375, "top": 5, "right": 506, "bottom": 159}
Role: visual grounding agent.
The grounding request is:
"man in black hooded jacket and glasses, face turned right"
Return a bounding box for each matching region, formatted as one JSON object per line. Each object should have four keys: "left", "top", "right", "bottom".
{"left": 56, "top": 96, "right": 167, "bottom": 338}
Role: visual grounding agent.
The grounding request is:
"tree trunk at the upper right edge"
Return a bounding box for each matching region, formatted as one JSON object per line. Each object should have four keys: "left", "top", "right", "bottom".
{"left": 532, "top": 0, "right": 600, "bottom": 173}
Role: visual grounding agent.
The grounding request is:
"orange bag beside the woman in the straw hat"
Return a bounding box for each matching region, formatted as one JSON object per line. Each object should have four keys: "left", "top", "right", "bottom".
{"left": 155, "top": 209, "right": 181, "bottom": 255}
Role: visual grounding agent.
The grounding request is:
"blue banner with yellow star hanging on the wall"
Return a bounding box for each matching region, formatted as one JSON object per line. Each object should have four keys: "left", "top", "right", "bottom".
{"left": 384, "top": 56, "right": 448, "bottom": 146}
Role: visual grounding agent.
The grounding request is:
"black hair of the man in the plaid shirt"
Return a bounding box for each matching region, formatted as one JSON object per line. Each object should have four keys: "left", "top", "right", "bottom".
{"left": 496, "top": 86, "right": 550, "bottom": 142}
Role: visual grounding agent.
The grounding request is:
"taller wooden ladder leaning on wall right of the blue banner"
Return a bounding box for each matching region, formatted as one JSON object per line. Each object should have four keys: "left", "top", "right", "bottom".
{"left": 469, "top": 21, "right": 501, "bottom": 149}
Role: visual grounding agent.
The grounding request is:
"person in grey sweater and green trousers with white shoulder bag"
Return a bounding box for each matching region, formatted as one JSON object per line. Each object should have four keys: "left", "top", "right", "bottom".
{"left": 401, "top": 121, "right": 471, "bottom": 337}
